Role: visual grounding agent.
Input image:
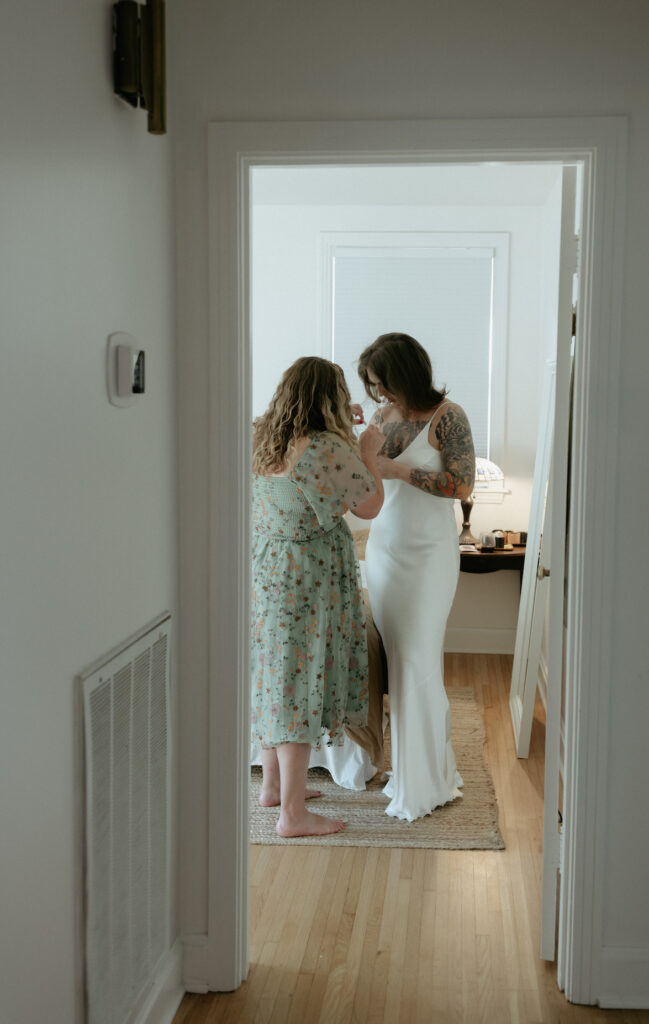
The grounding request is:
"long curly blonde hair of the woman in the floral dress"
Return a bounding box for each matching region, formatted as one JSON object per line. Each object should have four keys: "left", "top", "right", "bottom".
{"left": 253, "top": 355, "right": 358, "bottom": 476}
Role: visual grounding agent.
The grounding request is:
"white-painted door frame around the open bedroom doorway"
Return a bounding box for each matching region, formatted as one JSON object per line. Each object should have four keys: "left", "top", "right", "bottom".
{"left": 195, "top": 118, "right": 626, "bottom": 1004}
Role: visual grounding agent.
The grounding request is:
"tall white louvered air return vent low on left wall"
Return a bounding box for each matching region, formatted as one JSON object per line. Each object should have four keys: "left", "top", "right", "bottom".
{"left": 81, "top": 615, "right": 171, "bottom": 1024}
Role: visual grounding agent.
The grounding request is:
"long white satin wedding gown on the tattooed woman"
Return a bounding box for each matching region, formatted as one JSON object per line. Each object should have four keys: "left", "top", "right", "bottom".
{"left": 365, "top": 411, "right": 463, "bottom": 821}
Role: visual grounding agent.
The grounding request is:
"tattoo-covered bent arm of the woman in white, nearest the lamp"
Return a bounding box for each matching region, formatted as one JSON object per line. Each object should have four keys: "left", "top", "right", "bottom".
{"left": 409, "top": 406, "right": 475, "bottom": 499}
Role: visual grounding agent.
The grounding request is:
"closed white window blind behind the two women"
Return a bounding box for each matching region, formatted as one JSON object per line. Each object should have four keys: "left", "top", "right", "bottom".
{"left": 332, "top": 246, "right": 493, "bottom": 458}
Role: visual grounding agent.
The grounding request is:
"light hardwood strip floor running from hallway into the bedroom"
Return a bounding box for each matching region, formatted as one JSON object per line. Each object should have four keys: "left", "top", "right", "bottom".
{"left": 174, "top": 654, "right": 649, "bottom": 1024}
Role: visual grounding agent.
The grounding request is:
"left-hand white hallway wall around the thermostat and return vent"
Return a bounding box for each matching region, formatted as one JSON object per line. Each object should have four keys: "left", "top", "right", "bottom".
{"left": 0, "top": 8, "right": 176, "bottom": 1024}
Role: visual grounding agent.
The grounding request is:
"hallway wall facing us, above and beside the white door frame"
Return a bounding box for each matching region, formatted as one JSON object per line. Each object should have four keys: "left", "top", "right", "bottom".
{"left": 170, "top": 0, "right": 649, "bottom": 1001}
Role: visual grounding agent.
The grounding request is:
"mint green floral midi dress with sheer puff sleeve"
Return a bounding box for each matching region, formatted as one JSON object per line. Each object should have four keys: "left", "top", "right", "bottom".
{"left": 251, "top": 431, "right": 376, "bottom": 748}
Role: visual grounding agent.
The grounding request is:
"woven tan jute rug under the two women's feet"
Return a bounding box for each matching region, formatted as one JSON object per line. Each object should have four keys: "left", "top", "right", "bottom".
{"left": 250, "top": 686, "right": 505, "bottom": 850}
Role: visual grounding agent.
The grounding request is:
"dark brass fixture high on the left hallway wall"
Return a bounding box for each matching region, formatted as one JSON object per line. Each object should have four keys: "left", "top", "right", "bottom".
{"left": 113, "top": 0, "right": 167, "bottom": 135}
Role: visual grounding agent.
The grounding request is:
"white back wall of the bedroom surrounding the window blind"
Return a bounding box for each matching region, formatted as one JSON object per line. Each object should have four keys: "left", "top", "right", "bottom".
{"left": 252, "top": 190, "right": 561, "bottom": 653}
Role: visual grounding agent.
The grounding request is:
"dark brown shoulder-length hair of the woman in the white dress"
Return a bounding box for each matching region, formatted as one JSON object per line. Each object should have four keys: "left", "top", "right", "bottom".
{"left": 358, "top": 332, "right": 446, "bottom": 414}
